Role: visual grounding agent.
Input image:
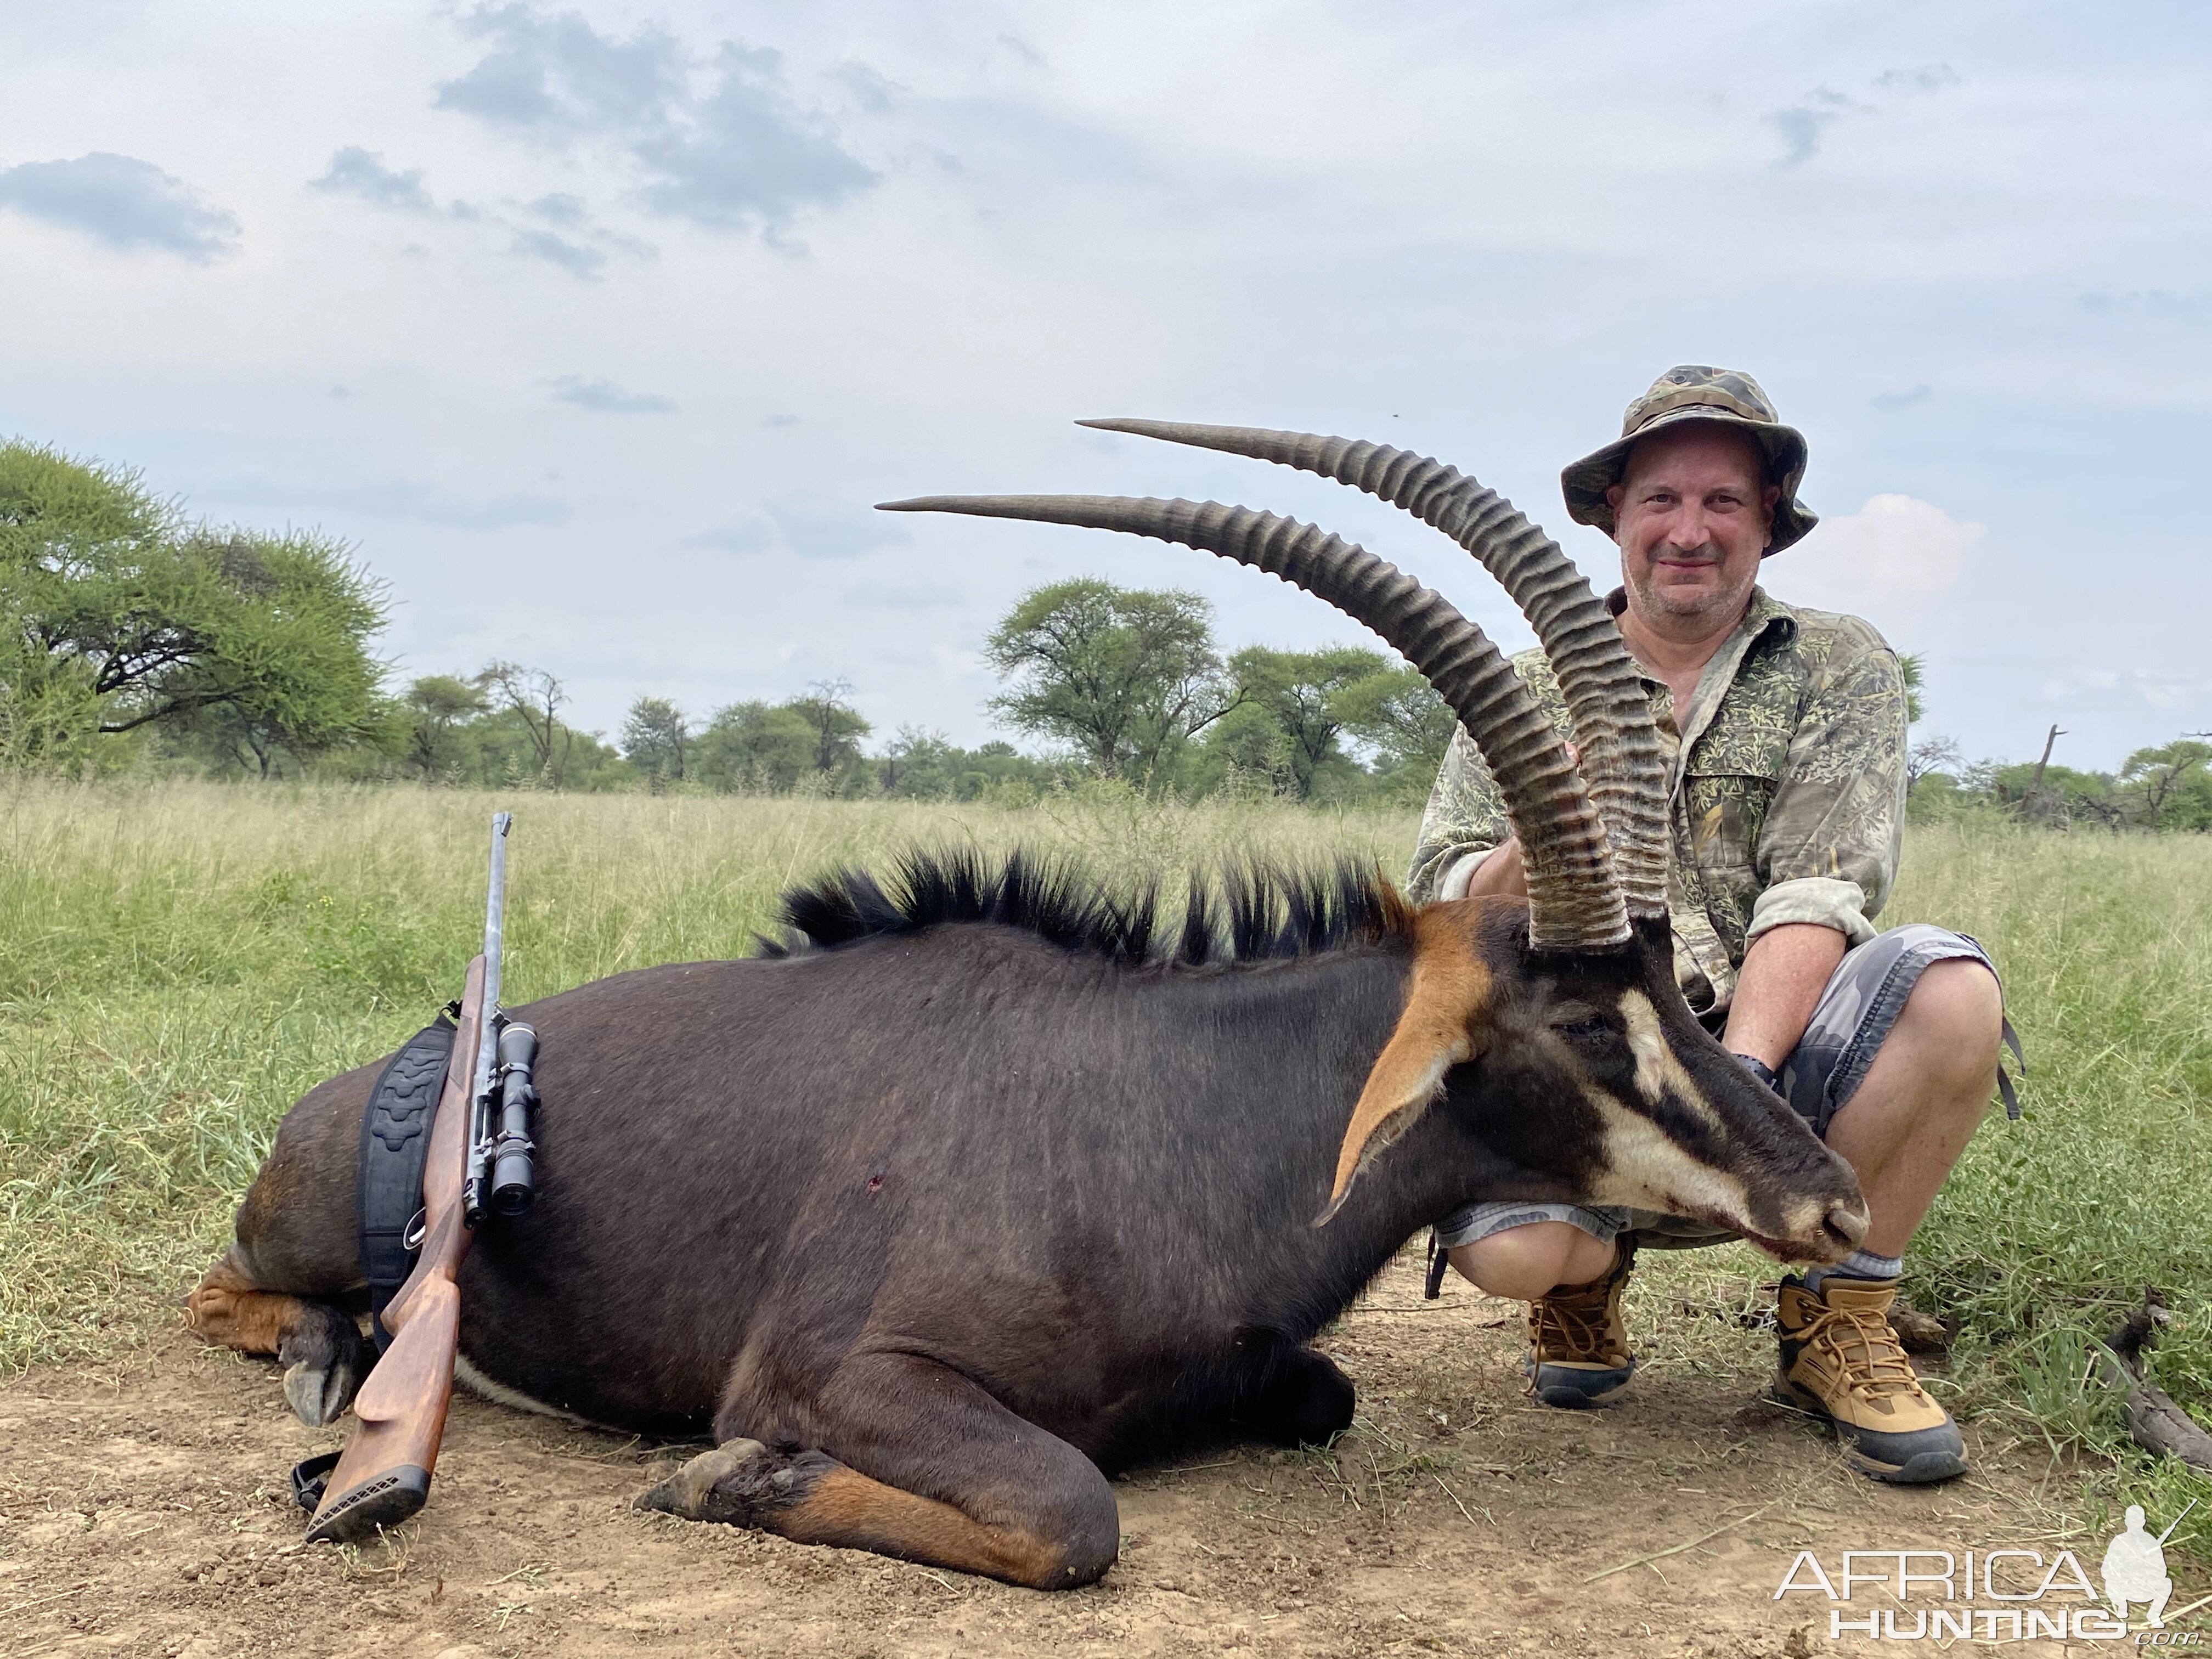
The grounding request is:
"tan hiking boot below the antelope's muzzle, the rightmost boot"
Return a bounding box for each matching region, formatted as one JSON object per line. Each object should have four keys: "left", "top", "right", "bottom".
{"left": 1774, "top": 1274, "right": 1966, "bottom": 1484}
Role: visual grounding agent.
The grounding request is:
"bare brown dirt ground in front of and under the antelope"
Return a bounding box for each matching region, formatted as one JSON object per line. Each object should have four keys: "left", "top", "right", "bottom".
{"left": 0, "top": 1254, "right": 2205, "bottom": 1659}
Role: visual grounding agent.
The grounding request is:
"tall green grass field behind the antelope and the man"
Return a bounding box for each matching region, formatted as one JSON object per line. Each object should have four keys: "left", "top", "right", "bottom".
{"left": 0, "top": 783, "right": 2212, "bottom": 1548}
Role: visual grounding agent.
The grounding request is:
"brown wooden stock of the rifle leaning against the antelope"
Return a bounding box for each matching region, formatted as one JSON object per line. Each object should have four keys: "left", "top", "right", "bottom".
{"left": 307, "top": 956, "right": 487, "bottom": 1544}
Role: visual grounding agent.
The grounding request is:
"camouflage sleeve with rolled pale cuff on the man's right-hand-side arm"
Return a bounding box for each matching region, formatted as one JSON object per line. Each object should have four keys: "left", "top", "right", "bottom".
{"left": 1745, "top": 624, "right": 1907, "bottom": 945}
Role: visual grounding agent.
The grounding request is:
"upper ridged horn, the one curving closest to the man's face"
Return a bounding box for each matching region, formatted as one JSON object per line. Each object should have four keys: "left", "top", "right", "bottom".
{"left": 1077, "top": 420, "right": 1672, "bottom": 918}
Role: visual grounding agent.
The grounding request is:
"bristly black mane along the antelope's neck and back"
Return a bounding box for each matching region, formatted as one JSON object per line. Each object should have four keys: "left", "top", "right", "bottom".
{"left": 761, "top": 849, "right": 1411, "bottom": 967}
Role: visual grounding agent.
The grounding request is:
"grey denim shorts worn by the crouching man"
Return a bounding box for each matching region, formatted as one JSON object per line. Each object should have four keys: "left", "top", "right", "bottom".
{"left": 1436, "top": 922, "right": 2019, "bottom": 1250}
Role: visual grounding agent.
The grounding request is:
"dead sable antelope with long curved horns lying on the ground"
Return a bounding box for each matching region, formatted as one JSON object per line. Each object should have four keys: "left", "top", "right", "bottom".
{"left": 193, "top": 422, "right": 1867, "bottom": 1588}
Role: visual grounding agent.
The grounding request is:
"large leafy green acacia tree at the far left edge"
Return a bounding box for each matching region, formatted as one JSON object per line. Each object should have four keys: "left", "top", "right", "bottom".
{"left": 0, "top": 442, "right": 385, "bottom": 770}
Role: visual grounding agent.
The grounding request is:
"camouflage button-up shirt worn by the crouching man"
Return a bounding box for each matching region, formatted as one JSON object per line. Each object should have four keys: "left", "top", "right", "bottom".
{"left": 1407, "top": 589, "right": 1905, "bottom": 1015}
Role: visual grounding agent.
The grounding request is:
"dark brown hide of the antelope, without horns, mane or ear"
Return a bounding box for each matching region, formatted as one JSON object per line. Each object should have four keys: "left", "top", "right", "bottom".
{"left": 199, "top": 862, "right": 1858, "bottom": 1582}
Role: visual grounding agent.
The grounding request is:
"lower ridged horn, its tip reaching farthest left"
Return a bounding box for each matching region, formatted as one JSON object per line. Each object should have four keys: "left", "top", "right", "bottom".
{"left": 883, "top": 495, "right": 1628, "bottom": 951}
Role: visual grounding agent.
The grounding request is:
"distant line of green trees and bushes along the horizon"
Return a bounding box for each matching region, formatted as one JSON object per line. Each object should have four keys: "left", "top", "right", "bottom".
{"left": 0, "top": 440, "right": 2212, "bottom": 832}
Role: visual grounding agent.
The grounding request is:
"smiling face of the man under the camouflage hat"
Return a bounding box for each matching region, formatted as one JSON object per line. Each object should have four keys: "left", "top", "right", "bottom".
{"left": 1606, "top": 420, "right": 1781, "bottom": 633}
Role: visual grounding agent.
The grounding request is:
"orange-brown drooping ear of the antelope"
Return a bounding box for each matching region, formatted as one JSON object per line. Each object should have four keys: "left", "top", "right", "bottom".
{"left": 1314, "top": 902, "right": 1491, "bottom": 1228}
